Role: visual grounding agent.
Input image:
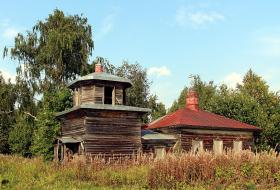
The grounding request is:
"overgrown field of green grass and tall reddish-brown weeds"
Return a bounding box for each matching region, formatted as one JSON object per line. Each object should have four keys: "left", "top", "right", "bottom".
{"left": 0, "top": 151, "right": 280, "bottom": 190}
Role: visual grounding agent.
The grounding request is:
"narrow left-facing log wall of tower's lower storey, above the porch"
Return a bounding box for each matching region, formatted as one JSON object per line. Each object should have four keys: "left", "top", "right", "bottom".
{"left": 61, "top": 117, "right": 85, "bottom": 137}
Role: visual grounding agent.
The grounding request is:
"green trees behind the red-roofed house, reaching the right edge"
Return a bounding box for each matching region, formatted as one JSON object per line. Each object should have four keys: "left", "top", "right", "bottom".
{"left": 169, "top": 70, "right": 280, "bottom": 151}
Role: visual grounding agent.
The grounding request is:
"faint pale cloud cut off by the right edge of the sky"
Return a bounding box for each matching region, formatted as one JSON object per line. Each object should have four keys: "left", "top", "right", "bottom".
{"left": 257, "top": 35, "right": 280, "bottom": 57}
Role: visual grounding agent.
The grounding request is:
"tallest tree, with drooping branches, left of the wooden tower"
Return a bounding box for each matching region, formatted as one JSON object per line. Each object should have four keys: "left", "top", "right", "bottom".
{"left": 1, "top": 9, "right": 93, "bottom": 159}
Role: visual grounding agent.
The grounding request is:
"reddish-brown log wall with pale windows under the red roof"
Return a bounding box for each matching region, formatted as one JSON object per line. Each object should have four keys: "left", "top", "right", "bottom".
{"left": 181, "top": 131, "right": 253, "bottom": 151}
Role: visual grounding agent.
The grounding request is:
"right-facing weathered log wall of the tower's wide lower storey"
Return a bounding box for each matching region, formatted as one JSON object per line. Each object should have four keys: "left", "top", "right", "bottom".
{"left": 84, "top": 110, "right": 141, "bottom": 156}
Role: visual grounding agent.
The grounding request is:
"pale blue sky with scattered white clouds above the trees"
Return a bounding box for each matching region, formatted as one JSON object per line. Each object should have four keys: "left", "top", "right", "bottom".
{"left": 0, "top": 0, "right": 280, "bottom": 107}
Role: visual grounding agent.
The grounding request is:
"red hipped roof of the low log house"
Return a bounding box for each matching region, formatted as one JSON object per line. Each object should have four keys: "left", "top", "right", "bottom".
{"left": 147, "top": 108, "right": 261, "bottom": 131}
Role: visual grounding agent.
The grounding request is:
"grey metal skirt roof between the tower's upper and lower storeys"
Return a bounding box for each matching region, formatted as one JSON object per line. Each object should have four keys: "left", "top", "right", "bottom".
{"left": 56, "top": 104, "right": 151, "bottom": 117}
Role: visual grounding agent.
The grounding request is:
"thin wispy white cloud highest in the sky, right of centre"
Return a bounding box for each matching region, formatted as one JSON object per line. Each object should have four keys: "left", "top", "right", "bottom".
{"left": 175, "top": 7, "right": 225, "bottom": 27}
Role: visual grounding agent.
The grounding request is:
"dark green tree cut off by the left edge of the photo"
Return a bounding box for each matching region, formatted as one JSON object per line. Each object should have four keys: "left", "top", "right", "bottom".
{"left": 0, "top": 73, "right": 16, "bottom": 153}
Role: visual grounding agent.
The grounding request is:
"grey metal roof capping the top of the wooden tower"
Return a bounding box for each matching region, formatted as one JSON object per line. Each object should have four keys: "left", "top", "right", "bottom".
{"left": 68, "top": 72, "right": 132, "bottom": 88}
